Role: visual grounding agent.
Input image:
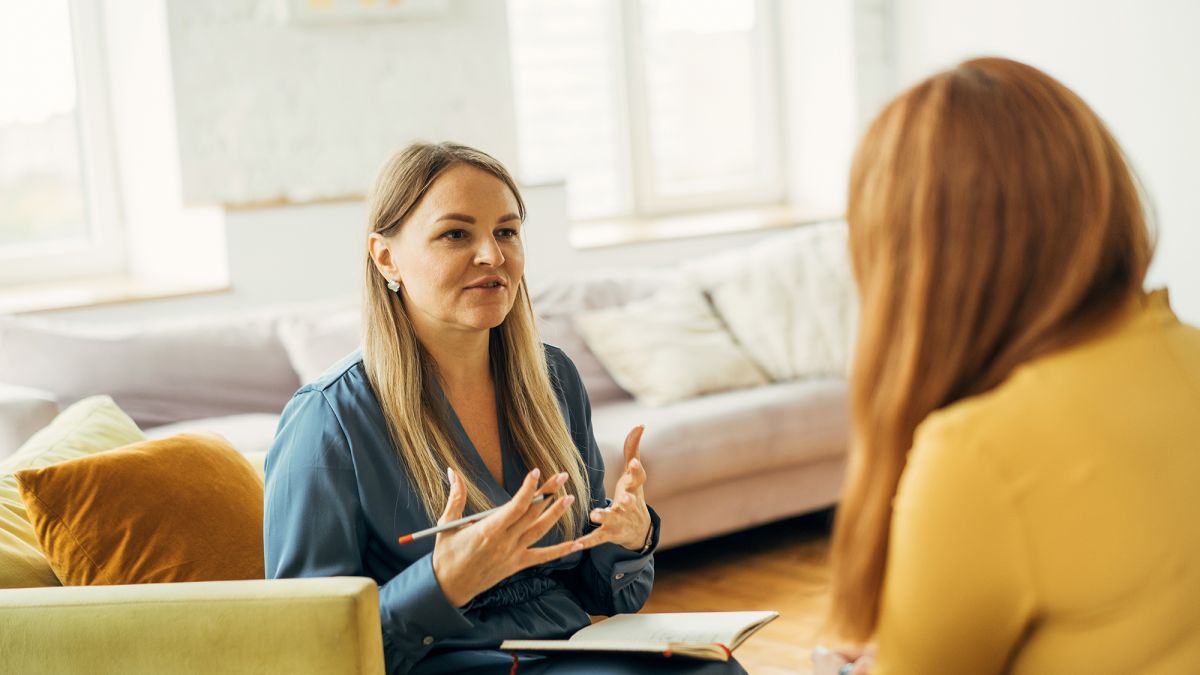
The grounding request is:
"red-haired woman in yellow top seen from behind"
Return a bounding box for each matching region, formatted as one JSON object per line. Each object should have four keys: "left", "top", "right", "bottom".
{"left": 814, "top": 59, "right": 1200, "bottom": 675}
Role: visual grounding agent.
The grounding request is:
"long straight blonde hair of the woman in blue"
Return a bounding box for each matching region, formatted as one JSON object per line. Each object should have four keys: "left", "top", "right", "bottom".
{"left": 362, "top": 143, "right": 590, "bottom": 537}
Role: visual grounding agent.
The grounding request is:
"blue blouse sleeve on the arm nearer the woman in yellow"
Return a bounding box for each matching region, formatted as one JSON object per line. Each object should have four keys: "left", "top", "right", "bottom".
{"left": 547, "top": 352, "right": 661, "bottom": 616}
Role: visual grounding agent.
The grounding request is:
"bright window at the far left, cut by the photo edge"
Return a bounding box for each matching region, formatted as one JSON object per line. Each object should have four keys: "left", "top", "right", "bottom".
{"left": 0, "top": 0, "right": 124, "bottom": 285}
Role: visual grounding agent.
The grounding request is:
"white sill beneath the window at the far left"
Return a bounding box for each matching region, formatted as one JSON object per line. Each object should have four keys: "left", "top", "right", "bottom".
{"left": 0, "top": 276, "right": 230, "bottom": 313}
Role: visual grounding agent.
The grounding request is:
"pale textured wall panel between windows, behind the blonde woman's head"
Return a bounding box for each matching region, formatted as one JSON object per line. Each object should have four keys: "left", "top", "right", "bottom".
{"left": 164, "top": 0, "right": 516, "bottom": 204}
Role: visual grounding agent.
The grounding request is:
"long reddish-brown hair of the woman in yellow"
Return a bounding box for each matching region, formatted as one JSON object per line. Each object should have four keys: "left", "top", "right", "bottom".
{"left": 830, "top": 59, "right": 1152, "bottom": 640}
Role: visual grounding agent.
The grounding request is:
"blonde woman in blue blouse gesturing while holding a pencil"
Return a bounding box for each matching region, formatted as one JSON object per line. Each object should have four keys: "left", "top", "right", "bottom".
{"left": 264, "top": 143, "right": 742, "bottom": 673}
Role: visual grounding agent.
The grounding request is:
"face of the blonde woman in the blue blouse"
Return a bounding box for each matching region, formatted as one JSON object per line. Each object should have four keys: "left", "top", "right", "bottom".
{"left": 371, "top": 165, "right": 524, "bottom": 334}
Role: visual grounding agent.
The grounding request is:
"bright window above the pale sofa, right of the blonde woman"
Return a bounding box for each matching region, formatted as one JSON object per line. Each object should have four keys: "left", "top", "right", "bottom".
{"left": 509, "top": 0, "right": 784, "bottom": 220}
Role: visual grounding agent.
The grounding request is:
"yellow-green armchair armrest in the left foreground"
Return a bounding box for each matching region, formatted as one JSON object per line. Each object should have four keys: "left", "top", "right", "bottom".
{"left": 0, "top": 577, "right": 384, "bottom": 675}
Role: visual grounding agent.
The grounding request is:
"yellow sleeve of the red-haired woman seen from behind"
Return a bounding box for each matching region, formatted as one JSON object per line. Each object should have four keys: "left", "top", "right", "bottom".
{"left": 872, "top": 415, "right": 1036, "bottom": 675}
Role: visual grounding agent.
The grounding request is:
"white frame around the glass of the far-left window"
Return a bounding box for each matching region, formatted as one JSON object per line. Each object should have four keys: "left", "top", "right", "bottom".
{"left": 0, "top": 0, "right": 127, "bottom": 287}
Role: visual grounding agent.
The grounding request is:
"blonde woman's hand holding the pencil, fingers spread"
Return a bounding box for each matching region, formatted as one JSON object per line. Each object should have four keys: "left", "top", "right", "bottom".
{"left": 433, "top": 468, "right": 583, "bottom": 607}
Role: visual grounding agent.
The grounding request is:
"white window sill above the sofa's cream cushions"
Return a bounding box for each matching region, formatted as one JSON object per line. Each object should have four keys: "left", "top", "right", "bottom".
{"left": 568, "top": 207, "right": 842, "bottom": 250}
